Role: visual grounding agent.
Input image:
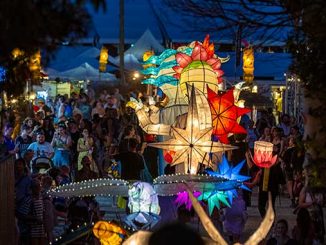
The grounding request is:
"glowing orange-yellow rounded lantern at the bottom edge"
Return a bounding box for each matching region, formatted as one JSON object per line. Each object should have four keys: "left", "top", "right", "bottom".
{"left": 93, "top": 221, "right": 126, "bottom": 245}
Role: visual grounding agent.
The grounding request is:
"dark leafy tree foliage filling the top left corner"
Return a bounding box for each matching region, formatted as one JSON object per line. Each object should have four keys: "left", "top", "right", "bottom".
{"left": 0, "top": 0, "right": 106, "bottom": 95}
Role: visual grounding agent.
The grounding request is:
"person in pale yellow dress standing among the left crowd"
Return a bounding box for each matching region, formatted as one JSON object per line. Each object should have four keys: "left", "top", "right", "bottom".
{"left": 77, "top": 128, "right": 94, "bottom": 170}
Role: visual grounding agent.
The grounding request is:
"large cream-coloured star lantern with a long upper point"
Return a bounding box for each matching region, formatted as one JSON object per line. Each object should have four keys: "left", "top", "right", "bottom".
{"left": 149, "top": 86, "right": 236, "bottom": 174}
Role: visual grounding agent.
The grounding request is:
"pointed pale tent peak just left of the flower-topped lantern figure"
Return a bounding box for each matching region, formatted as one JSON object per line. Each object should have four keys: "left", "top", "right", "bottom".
{"left": 125, "top": 29, "right": 164, "bottom": 60}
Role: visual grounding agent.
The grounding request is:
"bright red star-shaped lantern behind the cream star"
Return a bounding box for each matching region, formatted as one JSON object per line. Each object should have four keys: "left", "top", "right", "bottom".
{"left": 207, "top": 88, "right": 250, "bottom": 144}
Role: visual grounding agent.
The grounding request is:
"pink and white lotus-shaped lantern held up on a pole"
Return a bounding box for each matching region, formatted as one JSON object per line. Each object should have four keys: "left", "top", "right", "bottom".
{"left": 253, "top": 141, "right": 277, "bottom": 168}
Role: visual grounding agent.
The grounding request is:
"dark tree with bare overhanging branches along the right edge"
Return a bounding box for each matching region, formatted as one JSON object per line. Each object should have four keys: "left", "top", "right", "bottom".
{"left": 164, "top": 0, "right": 326, "bottom": 188}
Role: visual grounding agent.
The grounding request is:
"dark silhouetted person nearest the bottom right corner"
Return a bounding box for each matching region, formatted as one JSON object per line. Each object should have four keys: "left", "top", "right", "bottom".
{"left": 292, "top": 208, "right": 316, "bottom": 245}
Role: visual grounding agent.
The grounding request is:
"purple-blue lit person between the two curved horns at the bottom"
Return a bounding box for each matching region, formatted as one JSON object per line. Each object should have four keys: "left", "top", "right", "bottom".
{"left": 222, "top": 191, "right": 248, "bottom": 244}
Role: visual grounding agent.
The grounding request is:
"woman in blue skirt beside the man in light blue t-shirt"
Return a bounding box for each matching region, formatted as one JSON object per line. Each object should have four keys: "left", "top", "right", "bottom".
{"left": 51, "top": 123, "right": 71, "bottom": 167}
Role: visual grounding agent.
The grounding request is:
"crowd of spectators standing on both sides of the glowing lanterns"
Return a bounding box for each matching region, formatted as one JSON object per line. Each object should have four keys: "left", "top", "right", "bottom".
{"left": 0, "top": 85, "right": 324, "bottom": 244}
